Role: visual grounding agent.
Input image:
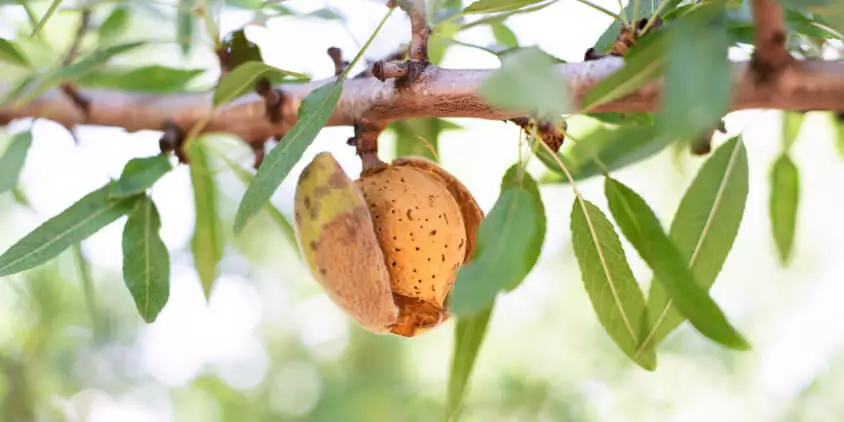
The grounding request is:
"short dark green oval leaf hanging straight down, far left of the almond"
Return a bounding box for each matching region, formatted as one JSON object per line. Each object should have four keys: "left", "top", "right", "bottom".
{"left": 123, "top": 196, "right": 170, "bottom": 323}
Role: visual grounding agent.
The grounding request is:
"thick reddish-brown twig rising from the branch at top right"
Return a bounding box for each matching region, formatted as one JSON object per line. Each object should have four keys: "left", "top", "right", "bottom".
{"left": 751, "top": 0, "right": 793, "bottom": 82}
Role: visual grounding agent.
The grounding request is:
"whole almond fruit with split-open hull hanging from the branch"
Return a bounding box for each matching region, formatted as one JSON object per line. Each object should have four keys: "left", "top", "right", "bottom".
{"left": 295, "top": 152, "right": 483, "bottom": 337}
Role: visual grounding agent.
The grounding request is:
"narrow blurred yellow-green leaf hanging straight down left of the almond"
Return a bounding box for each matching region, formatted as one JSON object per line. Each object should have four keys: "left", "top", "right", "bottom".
{"left": 187, "top": 139, "right": 223, "bottom": 299}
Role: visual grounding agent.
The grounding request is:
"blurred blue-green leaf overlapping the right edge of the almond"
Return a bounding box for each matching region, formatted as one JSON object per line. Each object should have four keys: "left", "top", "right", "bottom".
{"left": 449, "top": 166, "right": 545, "bottom": 315}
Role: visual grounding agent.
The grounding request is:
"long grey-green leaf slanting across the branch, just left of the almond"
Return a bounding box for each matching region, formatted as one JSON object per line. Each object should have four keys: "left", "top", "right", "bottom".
{"left": 234, "top": 78, "right": 344, "bottom": 234}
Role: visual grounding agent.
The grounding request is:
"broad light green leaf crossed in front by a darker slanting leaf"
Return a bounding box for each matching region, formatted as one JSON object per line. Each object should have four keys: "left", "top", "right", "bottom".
{"left": 643, "top": 137, "right": 748, "bottom": 347}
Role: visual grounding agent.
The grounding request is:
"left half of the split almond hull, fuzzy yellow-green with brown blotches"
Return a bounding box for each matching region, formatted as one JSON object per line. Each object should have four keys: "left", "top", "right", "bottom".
{"left": 294, "top": 153, "right": 398, "bottom": 334}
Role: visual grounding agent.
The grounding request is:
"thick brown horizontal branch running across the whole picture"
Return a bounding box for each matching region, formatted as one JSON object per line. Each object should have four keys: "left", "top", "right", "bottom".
{"left": 0, "top": 57, "right": 844, "bottom": 142}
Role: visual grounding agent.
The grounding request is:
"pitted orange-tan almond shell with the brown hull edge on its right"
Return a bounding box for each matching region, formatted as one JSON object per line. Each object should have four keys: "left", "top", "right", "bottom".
{"left": 355, "top": 158, "right": 483, "bottom": 337}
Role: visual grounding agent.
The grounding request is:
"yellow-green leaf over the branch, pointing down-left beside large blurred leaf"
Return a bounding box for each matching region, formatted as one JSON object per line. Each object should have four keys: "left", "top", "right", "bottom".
{"left": 580, "top": 30, "right": 667, "bottom": 112}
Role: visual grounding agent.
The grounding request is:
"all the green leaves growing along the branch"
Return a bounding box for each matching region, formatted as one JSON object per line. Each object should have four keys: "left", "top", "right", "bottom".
{"left": 0, "top": 0, "right": 844, "bottom": 418}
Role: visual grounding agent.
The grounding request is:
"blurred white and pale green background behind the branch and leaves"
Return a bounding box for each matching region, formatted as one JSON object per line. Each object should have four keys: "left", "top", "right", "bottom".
{"left": 0, "top": 0, "right": 844, "bottom": 422}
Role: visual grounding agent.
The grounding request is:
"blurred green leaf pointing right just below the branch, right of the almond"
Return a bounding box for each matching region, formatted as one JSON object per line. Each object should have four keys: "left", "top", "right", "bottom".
{"left": 537, "top": 120, "right": 671, "bottom": 184}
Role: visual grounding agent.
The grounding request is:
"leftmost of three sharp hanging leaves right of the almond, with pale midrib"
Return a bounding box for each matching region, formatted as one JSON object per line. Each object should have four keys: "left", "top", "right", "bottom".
{"left": 571, "top": 199, "right": 656, "bottom": 371}
